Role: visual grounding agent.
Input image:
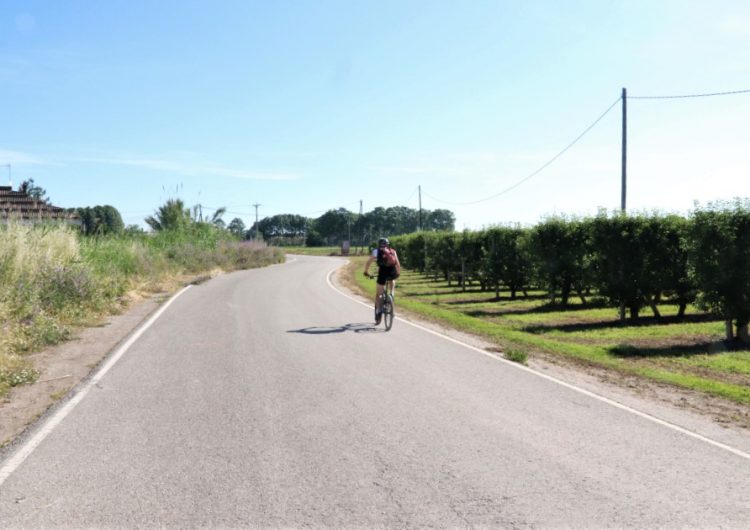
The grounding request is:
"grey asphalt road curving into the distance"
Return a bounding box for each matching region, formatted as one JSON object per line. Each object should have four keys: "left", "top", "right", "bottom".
{"left": 0, "top": 257, "right": 750, "bottom": 528}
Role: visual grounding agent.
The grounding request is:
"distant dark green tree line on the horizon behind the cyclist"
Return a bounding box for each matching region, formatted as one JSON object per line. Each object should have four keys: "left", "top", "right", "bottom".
{"left": 253, "top": 206, "right": 456, "bottom": 247}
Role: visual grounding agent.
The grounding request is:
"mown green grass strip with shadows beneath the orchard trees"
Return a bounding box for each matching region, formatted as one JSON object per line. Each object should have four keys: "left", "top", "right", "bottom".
{"left": 352, "top": 258, "right": 750, "bottom": 404}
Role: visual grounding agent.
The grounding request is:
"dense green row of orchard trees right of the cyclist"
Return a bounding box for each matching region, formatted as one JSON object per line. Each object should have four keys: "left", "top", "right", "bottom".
{"left": 391, "top": 200, "right": 750, "bottom": 342}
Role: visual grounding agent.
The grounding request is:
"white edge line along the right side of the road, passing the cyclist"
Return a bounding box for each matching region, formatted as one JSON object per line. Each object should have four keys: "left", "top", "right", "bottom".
{"left": 326, "top": 266, "right": 750, "bottom": 460}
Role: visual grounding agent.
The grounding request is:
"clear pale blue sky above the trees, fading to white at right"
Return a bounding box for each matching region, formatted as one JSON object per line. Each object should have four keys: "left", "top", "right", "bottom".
{"left": 0, "top": 0, "right": 750, "bottom": 229}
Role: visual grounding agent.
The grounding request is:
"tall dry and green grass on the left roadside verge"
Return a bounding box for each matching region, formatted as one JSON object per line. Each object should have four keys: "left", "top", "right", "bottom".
{"left": 0, "top": 220, "right": 283, "bottom": 397}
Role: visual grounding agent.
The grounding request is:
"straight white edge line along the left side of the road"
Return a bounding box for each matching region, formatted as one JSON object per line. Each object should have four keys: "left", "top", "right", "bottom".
{"left": 0, "top": 285, "right": 190, "bottom": 486}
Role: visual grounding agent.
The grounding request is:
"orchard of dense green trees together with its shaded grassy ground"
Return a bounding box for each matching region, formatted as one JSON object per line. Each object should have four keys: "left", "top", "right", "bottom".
{"left": 353, "top": 201, "right": 750, "bottom": 404}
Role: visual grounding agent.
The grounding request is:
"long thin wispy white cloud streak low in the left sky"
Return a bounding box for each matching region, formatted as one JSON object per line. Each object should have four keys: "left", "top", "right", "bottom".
{"left": 76, "top": 158, "right": 300, "bottom": 180}
